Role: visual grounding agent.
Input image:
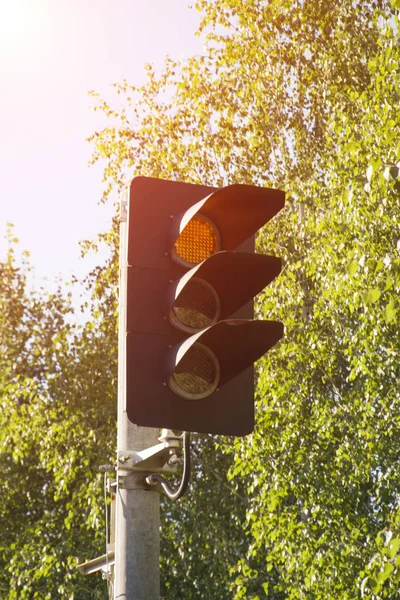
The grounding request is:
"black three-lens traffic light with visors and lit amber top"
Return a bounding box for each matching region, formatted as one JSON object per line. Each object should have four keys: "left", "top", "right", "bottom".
{"left": 126, "top": 177, "right": 284, "bottom": 435}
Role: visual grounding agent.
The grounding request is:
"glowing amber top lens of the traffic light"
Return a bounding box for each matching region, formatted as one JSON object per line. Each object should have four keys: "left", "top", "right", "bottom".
{"left": 171, "top": 215, "right": 221, "bottom": 267}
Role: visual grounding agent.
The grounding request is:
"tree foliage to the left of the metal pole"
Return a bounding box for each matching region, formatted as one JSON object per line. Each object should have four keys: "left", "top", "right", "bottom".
{"left": 0, "top": 232, "right": 115, "bottom": 600}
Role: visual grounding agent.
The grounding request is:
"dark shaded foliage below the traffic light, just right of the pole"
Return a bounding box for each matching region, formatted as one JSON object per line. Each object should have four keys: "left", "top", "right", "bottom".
{"left": 161, "top": 435, "right": 247, "bottom": 600}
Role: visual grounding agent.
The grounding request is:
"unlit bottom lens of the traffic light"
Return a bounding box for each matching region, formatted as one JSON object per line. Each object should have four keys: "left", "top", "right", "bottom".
{"left": 169, "top": 343, "right": 220, "bottom": 400}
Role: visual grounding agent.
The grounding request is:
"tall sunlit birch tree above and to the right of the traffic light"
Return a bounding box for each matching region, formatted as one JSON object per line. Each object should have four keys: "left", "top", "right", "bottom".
{"left": 83, "top": 0, "right": 400, "bottom": 600}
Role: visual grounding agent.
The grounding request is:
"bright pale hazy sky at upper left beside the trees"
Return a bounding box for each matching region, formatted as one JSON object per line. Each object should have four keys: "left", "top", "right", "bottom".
{"left": 0, "top": 0, "right": 202, "bottom": 286}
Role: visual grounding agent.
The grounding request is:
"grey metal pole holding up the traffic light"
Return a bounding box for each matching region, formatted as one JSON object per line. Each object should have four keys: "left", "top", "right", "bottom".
{"left": 114, "top": 191, "right": 160, "bottom": 600}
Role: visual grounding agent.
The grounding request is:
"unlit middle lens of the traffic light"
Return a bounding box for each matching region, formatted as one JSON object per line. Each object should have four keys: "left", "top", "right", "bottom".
{"left": 170, "top": 277, "right": 220, "bottom": 333}
